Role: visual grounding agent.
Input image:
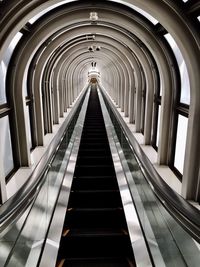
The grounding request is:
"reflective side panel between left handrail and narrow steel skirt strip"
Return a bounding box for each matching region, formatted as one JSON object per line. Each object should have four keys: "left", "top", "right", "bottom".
{"left": 0, "top": 87, "right": 88, "bottom": 267}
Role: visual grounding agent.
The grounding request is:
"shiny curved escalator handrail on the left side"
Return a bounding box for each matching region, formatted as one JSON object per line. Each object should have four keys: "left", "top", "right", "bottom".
{"left": 0, "top": 86, "right": 88, "bottom": 233}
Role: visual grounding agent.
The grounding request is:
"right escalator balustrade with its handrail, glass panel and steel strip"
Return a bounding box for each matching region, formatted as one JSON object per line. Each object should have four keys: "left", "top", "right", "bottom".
{"left": 100, "top": 88, "right": 200, "bottom": 267}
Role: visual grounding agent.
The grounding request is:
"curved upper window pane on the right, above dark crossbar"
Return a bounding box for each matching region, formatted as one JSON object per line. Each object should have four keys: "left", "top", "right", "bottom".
{"left": 164, "top": 33, "right": 190, "bottom": 105}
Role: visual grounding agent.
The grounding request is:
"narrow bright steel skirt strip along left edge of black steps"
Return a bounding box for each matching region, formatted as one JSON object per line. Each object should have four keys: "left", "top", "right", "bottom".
{"left": 39, "top": 90, "right": 90, "bottom": 267}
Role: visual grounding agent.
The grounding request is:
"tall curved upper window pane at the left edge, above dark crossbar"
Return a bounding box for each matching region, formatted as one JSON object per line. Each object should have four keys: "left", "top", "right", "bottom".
{"left": 0, "top": 32, "right": 22, "bottom": 105}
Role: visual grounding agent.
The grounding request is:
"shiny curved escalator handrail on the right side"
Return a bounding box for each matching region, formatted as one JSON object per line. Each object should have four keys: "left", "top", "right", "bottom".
{"left": 99, "top": 86, "right": 200, "bottom": 243}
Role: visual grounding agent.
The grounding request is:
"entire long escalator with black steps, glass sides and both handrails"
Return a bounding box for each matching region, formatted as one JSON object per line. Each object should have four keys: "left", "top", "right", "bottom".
{"left": 0, "top": 86, "right": 200, "bottom": 267}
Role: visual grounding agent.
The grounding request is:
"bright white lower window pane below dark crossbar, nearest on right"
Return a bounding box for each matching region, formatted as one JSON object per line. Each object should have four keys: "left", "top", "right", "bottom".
{"left": 174, "top": 115, "right": 188, "bottom": 174}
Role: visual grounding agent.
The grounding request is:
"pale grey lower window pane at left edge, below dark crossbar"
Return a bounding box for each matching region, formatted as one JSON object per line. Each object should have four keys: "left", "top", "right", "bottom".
{"left": 0, "top": 116, "right": 14, "bottom": 176}
